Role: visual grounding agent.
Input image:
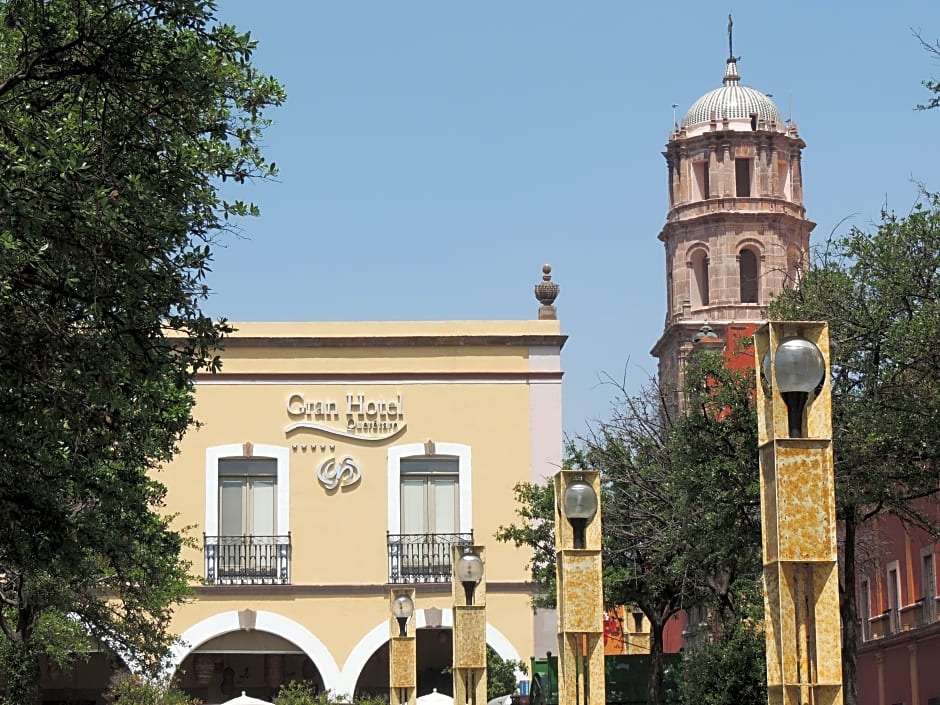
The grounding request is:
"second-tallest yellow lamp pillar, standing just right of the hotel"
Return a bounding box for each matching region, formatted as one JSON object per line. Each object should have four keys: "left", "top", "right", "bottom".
{"left": 554, "top": 470, "right": 606, "bottom": 705}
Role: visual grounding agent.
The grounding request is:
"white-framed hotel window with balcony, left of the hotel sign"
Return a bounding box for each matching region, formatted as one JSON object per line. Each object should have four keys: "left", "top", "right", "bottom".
{"left": 204, "top": 443, "right": 290, "bottom": 584}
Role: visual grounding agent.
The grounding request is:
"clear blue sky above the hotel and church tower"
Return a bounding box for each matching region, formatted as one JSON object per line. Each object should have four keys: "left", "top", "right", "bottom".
{"left": 206, "top": 0, "right": 940, "bottom": 436}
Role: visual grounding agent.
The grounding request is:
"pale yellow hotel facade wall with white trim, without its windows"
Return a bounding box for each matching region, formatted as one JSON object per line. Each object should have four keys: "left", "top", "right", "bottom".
{"left": 160, "top": 320, "right": 564, "bottom": 702}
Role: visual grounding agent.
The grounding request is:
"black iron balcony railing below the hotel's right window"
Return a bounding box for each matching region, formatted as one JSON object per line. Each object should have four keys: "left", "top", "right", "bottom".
{"left": 388, "top": 532, "right": 473, "bottom": 583}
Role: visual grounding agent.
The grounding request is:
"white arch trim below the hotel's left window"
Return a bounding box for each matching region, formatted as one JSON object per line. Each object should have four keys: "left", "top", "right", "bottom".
{"left": 165, "top": 610, "right": 342, "bottom": 690}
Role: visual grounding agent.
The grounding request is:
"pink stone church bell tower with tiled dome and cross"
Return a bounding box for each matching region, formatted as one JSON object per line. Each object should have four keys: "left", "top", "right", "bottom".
{"left": 652, "top": 30, "right": 815, "bottom": 408}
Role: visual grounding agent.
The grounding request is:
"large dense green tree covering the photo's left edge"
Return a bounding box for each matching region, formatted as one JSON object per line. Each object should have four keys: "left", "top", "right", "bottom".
{"left": 0, "top": 0, "right": 283, "bottom": 705}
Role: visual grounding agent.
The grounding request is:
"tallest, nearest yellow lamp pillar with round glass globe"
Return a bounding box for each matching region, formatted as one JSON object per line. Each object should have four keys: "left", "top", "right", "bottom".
{"left": 754, "top": 321, "right": 842, "bottom": 705}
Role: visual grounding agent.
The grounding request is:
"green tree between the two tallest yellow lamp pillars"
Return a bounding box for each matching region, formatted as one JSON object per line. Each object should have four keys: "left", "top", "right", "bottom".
{"left": 496, "top": 351, "right": 761, "bottom": 703}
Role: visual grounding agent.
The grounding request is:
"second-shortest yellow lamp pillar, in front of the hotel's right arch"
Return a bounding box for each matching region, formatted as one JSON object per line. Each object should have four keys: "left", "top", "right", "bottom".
{"left": 451, "top": 545, "right": 486, "bottom": 705}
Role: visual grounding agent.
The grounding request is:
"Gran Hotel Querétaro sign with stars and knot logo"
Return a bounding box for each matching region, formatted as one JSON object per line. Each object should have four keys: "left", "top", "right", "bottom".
{"left": 285, "top": 392, "right": 406, "bottom": 490}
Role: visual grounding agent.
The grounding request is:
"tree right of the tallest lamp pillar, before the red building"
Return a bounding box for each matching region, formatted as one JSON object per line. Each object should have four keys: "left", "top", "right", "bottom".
{"left": 771, "top": 193, "right": 940, "bottom": 705}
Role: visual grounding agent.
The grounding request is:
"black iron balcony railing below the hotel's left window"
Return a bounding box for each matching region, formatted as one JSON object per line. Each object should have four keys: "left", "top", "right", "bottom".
{"left": 205, "top": 534, "right": 291, "bottom": 585}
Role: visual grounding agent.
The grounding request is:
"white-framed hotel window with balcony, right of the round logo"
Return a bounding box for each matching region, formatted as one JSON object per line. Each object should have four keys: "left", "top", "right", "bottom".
{"left": 388, "top": 442, "right": 473, "bottom": 583}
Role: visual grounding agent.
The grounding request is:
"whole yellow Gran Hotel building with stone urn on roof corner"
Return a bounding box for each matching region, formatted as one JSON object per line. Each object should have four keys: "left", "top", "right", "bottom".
{"left": 161, "top": 284, "right": 565, "bottom": 703}
